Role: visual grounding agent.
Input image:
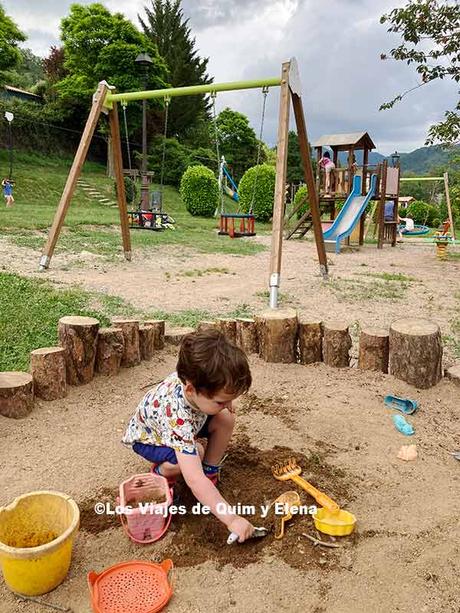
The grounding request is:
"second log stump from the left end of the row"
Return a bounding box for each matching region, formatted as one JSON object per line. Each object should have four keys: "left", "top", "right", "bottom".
{"left": 30, "top": 347, "right": 67, "bottom": 400}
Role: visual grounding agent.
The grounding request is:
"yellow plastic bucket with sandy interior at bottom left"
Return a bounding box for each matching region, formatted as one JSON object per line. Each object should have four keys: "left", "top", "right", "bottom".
{"left": 0, "top": 491, "right": 80, "bottom": 596}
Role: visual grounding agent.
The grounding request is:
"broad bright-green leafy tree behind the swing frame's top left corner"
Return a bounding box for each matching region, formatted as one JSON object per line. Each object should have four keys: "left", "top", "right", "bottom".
{"left": 56, "top": 4, "right": 166, "bottom": 109}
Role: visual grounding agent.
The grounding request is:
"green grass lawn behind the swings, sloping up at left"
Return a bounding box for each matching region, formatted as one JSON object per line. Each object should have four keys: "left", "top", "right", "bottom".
{"left": 0, "top": 151, "right": 270, "bottom": 258}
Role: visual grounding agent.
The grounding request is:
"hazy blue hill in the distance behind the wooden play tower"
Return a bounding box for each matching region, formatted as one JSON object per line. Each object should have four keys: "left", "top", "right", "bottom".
{"left": 339, "top": 146, "right": 460, "bottom": 176}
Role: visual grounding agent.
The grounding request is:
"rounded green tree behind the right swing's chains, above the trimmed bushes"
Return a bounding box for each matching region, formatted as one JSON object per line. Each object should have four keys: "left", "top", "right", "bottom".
{"left": 217, "top": 107, "right": 265, "bottom": 181}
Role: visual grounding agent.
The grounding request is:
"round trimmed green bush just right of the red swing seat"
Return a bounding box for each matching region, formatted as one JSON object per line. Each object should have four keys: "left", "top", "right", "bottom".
{"left": 238, "top": 164, "right": 276, "bottom": 221}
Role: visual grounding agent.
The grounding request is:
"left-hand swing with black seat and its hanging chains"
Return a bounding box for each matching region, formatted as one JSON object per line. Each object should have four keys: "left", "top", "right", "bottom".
{"left": 122, "top": 97, "right": 175, "bottom": 231}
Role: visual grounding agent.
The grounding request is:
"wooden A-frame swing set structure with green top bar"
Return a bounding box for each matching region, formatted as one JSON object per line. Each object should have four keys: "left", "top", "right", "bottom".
{"left": 39, "top": 58, "right": 328, "bottom": 308}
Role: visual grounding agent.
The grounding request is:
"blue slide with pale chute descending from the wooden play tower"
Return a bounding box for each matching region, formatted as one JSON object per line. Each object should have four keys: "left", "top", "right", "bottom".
{"left": 323, "top": 175, "right": 377, "bottom": 253}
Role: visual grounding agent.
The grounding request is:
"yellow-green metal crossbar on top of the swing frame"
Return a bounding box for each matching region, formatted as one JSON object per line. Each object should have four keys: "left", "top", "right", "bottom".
{"left": 104, "top": 77, "right": 281, "bottom": 109}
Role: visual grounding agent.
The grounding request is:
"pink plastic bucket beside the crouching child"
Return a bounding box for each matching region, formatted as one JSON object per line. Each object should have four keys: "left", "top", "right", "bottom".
{"left": 119, "top": 473, "right": 172, "bottom": 544}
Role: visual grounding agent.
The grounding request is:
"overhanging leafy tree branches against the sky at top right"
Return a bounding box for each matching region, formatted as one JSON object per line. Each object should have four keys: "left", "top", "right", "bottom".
{"left": 380, "top": 0, "right": 460, "bottom": 145}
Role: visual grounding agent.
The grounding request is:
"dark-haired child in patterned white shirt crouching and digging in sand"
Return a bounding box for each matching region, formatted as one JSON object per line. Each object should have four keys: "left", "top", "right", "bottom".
{"left": 123, "top": 330, "right": 254, "bottom": 542}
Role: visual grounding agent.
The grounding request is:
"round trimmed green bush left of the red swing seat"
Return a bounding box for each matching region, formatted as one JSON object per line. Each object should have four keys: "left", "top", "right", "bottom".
{"left": 180, "top": 166, "right": 219, "bottom": 217}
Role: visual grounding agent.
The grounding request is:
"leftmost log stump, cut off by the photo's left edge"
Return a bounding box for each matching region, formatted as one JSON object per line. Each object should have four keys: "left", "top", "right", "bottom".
{"left": 0, "top": 372, "right": 34, "bottom": 419}
